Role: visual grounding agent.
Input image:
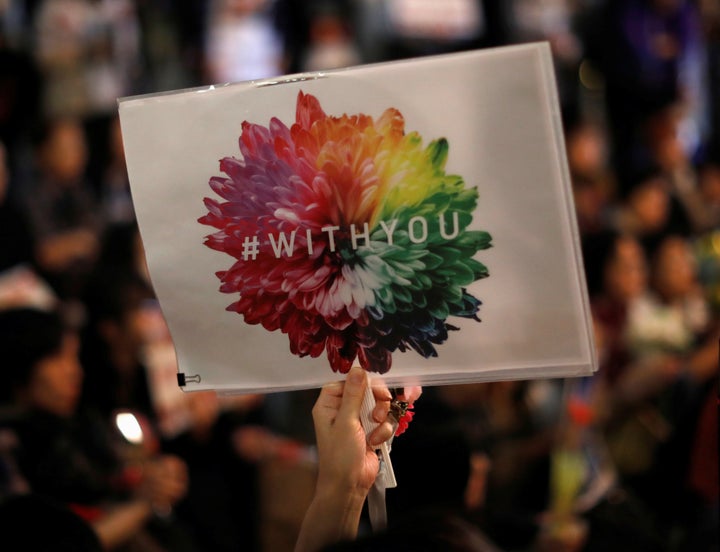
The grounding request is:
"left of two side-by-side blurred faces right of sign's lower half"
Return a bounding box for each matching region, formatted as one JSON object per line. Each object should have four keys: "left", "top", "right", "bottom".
{"left": 605, "top": 238, "right": 647, "bottom": 303}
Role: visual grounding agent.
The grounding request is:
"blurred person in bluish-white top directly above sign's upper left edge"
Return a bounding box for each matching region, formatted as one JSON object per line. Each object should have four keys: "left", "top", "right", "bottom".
{"left": 205, "top": 0, "right": 282, "bottom": 83}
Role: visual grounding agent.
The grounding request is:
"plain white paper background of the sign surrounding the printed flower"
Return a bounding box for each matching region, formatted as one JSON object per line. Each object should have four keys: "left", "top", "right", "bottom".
{"left": 120, "top": 44, "right": 596, "bottom": 392}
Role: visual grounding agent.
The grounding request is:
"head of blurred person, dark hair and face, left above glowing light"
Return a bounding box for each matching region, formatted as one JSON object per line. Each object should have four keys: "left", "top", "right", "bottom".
{"left": 0, "top": 308, "right": 83, "bottom": 417}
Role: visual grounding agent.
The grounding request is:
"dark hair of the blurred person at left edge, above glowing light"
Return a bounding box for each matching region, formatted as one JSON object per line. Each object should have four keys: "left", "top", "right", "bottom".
{"left": 0, "top": 308, "right": 66, "bottom": 399}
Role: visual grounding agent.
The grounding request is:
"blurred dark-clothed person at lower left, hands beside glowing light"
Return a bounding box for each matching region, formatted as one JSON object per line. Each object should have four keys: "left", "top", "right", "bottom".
{"left": 0, "top": 309, "right": 193, "bottom": 550}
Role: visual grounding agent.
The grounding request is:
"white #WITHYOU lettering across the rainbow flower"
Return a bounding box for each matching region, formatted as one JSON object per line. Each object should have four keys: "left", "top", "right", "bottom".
{"left": 235, "top": 212, "right": 460, "bottom": 261}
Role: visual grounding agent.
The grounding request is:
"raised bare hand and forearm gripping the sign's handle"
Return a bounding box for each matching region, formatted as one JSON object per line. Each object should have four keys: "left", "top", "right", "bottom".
{"left": 295, "top": 368, "right": 393, "bottom": 552}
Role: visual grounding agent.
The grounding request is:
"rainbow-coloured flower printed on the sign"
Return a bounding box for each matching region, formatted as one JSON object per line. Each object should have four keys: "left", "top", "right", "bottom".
{"left": 198, "top": 92, "right": 491, "bottom": 373}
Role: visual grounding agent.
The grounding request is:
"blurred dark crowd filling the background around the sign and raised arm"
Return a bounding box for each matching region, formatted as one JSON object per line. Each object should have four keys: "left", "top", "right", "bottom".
{"left": 0, "top": 0, "right": 720, "bottom": 552}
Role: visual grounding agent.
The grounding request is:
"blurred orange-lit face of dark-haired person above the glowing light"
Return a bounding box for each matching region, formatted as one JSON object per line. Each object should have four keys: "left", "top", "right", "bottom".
{"left": 23, "top": 334, "right": 82, "bottom": 417}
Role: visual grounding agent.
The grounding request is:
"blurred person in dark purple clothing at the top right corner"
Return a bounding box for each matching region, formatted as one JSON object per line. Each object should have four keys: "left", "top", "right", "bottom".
{"left": 585, "top": 0, "right": 705, "bottom": 189}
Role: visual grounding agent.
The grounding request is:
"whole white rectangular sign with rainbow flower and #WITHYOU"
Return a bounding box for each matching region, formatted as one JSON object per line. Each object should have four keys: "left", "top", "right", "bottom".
{"left": 120, "top": 44, "right": 596, "bottom": 392}
